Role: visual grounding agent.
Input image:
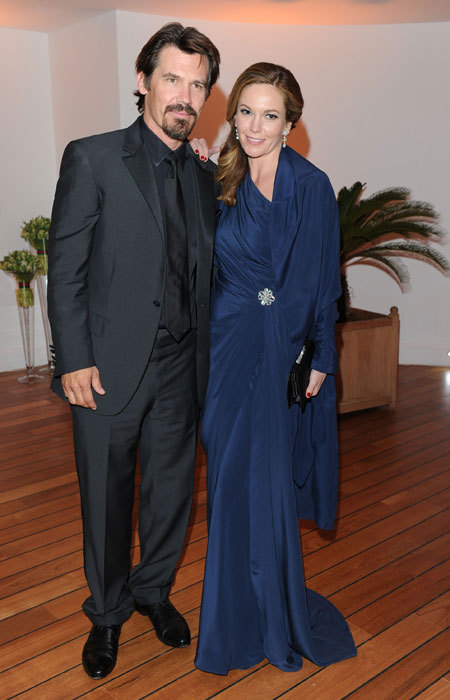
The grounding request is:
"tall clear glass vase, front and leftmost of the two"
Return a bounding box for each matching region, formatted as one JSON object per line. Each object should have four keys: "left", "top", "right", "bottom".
{"left": 14, "top": 275, "right": 44, "bottom": 384}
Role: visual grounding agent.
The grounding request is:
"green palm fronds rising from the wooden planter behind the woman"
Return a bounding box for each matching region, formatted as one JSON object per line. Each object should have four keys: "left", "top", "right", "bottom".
{"left": 337, "top": 182, "right": 450, "bottom": 319}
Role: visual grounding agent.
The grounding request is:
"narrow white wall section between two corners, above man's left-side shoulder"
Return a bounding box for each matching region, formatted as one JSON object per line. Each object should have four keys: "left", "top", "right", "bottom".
{"left": 49, "top": 12, "right": 120, "bottom": 167}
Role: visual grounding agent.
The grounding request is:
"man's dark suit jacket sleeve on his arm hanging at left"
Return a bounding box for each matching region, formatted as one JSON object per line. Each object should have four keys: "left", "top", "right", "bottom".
{"left": 48, "top": 142, "right": 100, "bottom": 376}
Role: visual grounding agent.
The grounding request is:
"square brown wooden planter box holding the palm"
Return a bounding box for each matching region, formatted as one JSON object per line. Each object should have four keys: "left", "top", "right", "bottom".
{"left": 336, "top": 306, "right": 399, "bottom": 413}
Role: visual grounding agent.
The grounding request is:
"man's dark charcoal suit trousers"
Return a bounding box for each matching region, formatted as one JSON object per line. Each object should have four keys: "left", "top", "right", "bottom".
{"left": 71, "top": 330, "right": 198, "bottom": 625}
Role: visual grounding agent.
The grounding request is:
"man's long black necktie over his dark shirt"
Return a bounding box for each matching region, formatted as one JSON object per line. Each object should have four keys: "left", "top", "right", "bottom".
{"left": 164, "top": 158, "right": 191, "bottom": 342}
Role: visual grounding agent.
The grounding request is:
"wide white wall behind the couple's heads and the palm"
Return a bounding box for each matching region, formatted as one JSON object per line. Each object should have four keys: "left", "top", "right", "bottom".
{"left": 117, "top": 12, "right": 450, "bottom": 365}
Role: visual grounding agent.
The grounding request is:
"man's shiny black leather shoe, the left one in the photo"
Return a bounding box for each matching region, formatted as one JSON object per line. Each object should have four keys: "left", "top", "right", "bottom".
{"left": 81, "top": 625, "right": 122, "bottom": 680}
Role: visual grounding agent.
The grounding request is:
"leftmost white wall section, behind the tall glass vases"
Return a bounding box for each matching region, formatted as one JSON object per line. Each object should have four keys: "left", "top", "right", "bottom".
{"left": 0, "top": 28, "right": 56, "bottom": 371}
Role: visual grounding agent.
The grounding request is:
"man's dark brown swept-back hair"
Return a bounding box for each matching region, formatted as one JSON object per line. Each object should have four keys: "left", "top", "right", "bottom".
{"left": 134, "top": 22, "right": 220, "bottom": 112}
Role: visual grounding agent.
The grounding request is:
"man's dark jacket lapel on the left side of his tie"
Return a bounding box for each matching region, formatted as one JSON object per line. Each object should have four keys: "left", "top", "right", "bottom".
{"left": 122, "top": 119, "right": 164, "bottom": 237}
